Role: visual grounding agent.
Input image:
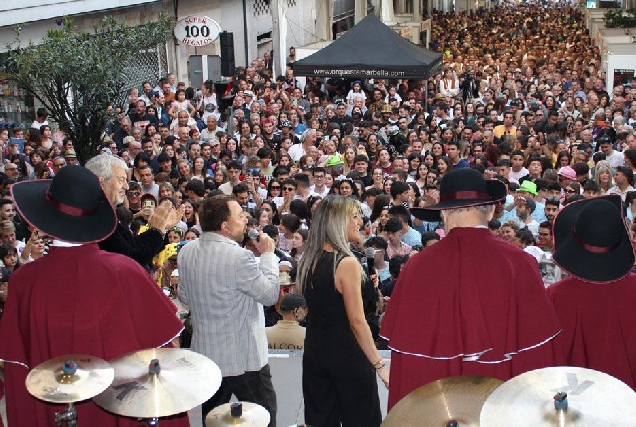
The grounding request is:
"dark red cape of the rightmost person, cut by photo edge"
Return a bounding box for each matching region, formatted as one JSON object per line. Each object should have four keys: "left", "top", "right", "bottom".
{"left": 546, "top": 273, "right": 636, "bottom": 391}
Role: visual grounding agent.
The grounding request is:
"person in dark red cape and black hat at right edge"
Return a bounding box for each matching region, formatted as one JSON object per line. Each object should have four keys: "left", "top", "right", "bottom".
{"left": 547, "top": 195, "right": 636, "bottom": 391}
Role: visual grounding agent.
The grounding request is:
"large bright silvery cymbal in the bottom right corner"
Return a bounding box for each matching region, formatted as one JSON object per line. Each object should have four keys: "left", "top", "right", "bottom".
{"left": 480, "top": 366, "right": 636, "bottom": 427}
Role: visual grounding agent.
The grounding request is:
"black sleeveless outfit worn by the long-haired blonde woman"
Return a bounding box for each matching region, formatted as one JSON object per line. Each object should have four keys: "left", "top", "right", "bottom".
{"left": 303, "top": 251, "right": 382, "bottom": 427}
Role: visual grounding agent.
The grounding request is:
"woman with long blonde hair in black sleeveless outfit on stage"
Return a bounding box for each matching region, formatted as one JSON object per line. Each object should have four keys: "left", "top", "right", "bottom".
{"left": 297, "top": 196, "right": 389, "bottom": 427}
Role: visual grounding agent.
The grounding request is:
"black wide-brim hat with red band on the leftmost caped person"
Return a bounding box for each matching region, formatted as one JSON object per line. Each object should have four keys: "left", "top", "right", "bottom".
{"left": 11, "top": 166, "right": 117, "bottom": 243}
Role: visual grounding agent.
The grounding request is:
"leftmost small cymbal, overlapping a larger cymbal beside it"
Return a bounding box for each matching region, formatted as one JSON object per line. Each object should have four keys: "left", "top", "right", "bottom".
{"left": 25, "top": 354, "right": 115, "bottom": 403}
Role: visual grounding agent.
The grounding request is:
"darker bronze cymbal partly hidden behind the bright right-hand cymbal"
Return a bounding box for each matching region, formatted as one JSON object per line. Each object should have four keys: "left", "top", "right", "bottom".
{"left": 382, "top": 375, "right": 503, "bottom": 427}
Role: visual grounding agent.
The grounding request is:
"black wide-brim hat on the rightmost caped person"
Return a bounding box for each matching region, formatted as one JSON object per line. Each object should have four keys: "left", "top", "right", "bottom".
{"left": 552, "top": 195, "right": 634, "bottom": 282}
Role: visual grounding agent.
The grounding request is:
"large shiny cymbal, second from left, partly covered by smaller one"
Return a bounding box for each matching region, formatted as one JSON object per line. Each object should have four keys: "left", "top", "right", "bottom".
{"left": 93, "top": 348, "right": 221, "bottom": 418}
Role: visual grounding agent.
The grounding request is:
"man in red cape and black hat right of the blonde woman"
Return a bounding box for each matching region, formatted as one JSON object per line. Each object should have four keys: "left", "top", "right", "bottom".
{"left": 380, "top": 169, "right": 561, "bottom": 409}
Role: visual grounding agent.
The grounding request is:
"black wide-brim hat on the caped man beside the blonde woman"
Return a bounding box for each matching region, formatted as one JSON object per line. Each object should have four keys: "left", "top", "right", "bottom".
{"left": 410, "top": 168, "right": 508, "bottom": 221}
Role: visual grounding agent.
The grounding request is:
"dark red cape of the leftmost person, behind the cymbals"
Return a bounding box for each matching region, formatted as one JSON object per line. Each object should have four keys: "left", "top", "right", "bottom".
{"left": 0, "top": 244, "right": 189, "bottom": 427}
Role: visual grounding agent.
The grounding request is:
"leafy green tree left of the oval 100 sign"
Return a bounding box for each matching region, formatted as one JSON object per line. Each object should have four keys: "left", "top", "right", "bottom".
{"left": 5, "top": 15, "right": 174, "bottom": 161}
